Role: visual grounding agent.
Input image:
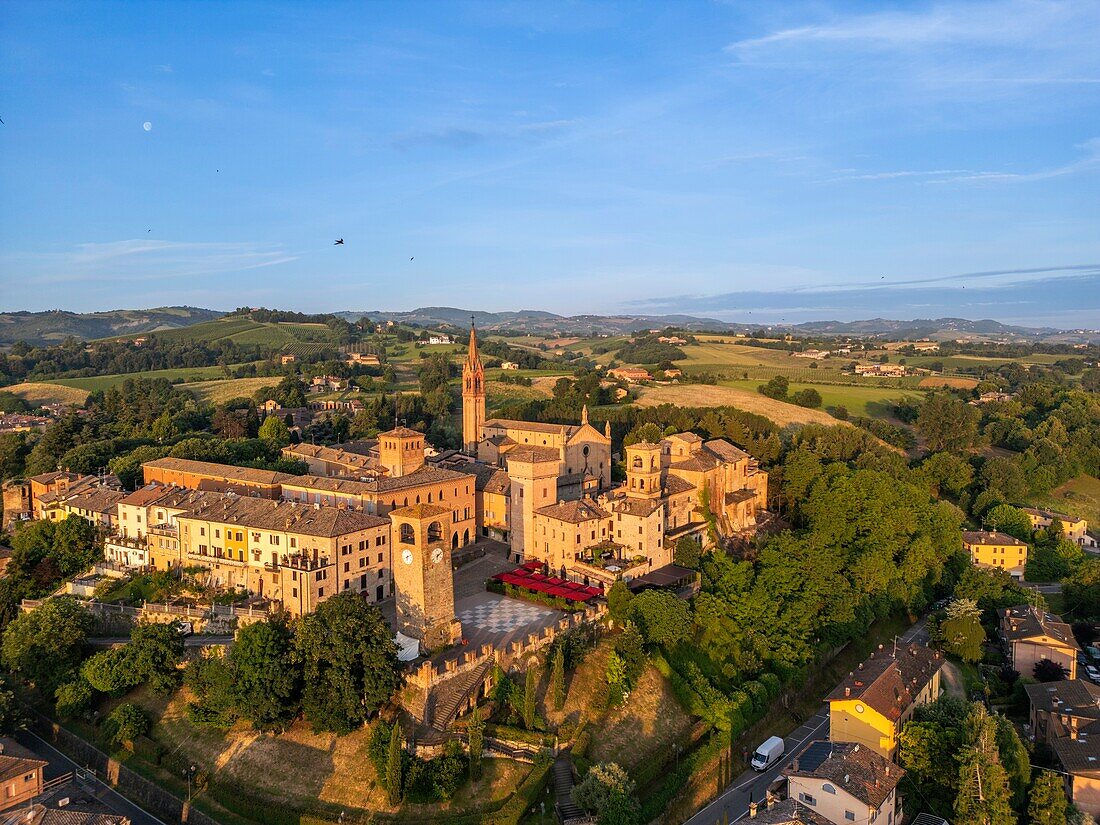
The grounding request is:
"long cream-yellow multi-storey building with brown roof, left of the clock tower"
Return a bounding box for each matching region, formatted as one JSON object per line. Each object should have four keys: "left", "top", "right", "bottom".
{"left": 176, "top": 496, "right": 393, "bottom": 616}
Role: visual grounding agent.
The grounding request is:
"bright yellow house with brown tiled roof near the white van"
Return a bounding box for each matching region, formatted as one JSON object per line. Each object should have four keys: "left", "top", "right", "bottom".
{"left": 826, "top": 645, "right": 944, "bottom": 759}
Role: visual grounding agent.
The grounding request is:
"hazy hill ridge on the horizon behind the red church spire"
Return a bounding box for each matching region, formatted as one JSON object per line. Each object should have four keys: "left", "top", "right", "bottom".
{"left": 337, "top": 307, "right": 747, "bottom": 334}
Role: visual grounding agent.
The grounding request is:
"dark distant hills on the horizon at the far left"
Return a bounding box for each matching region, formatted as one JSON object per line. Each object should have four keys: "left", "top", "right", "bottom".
{"left": 0, "top": 307, "right": 223, "bottom": 344}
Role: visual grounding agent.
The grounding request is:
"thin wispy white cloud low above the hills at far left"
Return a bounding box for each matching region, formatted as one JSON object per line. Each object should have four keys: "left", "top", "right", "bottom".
{"left": 0, "top": 239, "right": 299, "bottom": 284}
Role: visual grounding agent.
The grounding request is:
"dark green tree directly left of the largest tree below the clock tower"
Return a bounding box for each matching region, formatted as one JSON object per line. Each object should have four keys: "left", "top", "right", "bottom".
{"left": 231, "top": 618, "right": 301, "bottom": 730}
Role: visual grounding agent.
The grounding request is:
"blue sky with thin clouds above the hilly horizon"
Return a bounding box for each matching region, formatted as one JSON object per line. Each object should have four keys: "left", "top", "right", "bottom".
{"left": 0, "top": 0, "right": 1100, "bottom": 327}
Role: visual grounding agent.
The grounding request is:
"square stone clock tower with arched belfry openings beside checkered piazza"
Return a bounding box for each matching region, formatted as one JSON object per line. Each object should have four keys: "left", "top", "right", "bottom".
{"left": 389, "top": 504, "right": 462, "bottom": 650}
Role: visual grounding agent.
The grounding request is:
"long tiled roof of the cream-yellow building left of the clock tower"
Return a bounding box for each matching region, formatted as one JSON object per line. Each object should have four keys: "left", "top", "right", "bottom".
{"left": 177, "top": 496, "right": 388, "bottom": 538}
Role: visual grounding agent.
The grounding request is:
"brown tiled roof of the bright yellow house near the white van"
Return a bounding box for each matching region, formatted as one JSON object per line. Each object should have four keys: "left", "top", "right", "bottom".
{"left": 827, "top": 645, "right": 944, "bottom": 721}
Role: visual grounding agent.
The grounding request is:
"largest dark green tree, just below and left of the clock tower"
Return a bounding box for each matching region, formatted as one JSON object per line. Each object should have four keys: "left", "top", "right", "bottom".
{"left": 295, "top": 593, "right": 402, "bottom": 734}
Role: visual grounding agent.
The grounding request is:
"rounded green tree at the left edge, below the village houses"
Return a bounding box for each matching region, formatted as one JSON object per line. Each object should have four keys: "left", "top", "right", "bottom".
{"left": 2, "top": 596, "right": 92, "bottom": 695}
